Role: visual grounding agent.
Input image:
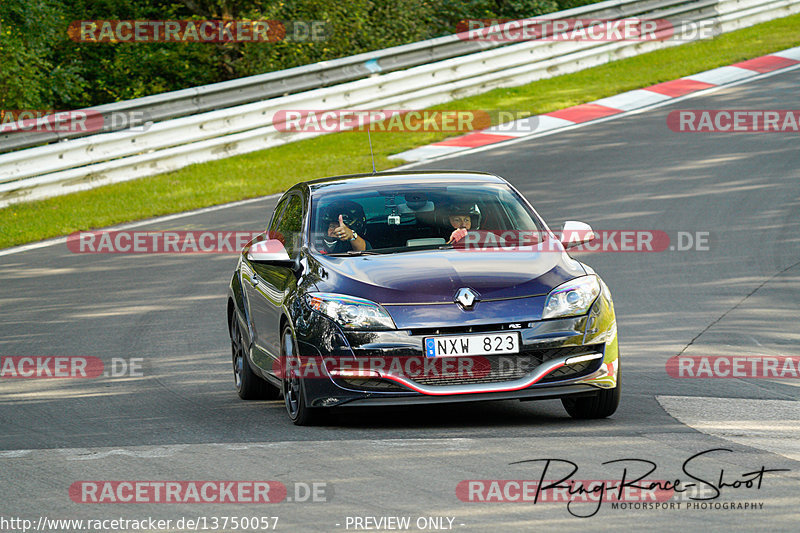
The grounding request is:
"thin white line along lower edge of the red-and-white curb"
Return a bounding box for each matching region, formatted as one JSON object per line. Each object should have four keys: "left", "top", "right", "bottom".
{"left": 392, "top": 61, "right": 800, "bottom": 171}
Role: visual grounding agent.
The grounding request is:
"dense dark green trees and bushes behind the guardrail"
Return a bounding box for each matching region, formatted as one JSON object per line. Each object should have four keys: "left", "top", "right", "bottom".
{"left": 0, "top": 0, "right": 591, "bottom": 109}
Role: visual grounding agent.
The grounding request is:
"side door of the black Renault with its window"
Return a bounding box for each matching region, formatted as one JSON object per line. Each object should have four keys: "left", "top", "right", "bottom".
{"left": 245, "top": 194, "right": 305, "bottom": 373}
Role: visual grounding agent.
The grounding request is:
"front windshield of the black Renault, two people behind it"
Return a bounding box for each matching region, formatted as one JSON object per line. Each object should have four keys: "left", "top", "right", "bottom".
{"left": 309, "top": 183, "right": 543, "bottom": 255}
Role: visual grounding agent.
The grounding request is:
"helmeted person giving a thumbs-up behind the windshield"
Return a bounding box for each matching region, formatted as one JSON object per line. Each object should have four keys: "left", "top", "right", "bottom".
{"left": 320, "top": 200, "right": 372, "bottom": 254}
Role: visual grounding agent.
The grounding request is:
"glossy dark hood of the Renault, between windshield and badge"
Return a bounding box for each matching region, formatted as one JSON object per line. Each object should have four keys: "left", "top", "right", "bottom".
{"left": 309, "top": 249, "right": 585, "bottom": 304}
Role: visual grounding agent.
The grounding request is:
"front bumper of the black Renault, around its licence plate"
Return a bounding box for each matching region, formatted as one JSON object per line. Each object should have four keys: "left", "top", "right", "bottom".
{"left": 295, "top": 291, "right": 619, "bottom": 407}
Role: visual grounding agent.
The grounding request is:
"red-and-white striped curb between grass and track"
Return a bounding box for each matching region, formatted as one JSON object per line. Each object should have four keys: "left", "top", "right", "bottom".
{"left": 389, "top": 46, "right": 800, "bottom": 161}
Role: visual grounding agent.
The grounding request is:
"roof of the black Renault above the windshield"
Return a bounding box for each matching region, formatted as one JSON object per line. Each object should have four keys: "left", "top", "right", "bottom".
{"left": 300, "top": 170, "right": 507, "bottom": 191}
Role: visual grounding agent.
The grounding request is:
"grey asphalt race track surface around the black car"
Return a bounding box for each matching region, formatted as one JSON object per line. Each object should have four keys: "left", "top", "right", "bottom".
{"left": 0, "top": 66, "right": 800, "bottom": 531}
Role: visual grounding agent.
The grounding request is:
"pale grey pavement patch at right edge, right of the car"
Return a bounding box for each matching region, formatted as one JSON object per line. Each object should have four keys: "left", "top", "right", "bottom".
{"left": 656, "top": 396, "right": 800, "bottom": 461}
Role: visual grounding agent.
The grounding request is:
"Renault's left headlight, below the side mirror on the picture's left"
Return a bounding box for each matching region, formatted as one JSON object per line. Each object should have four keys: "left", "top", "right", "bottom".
{"left": 306, "top": 292, "right": 395, "bottom": 329}
